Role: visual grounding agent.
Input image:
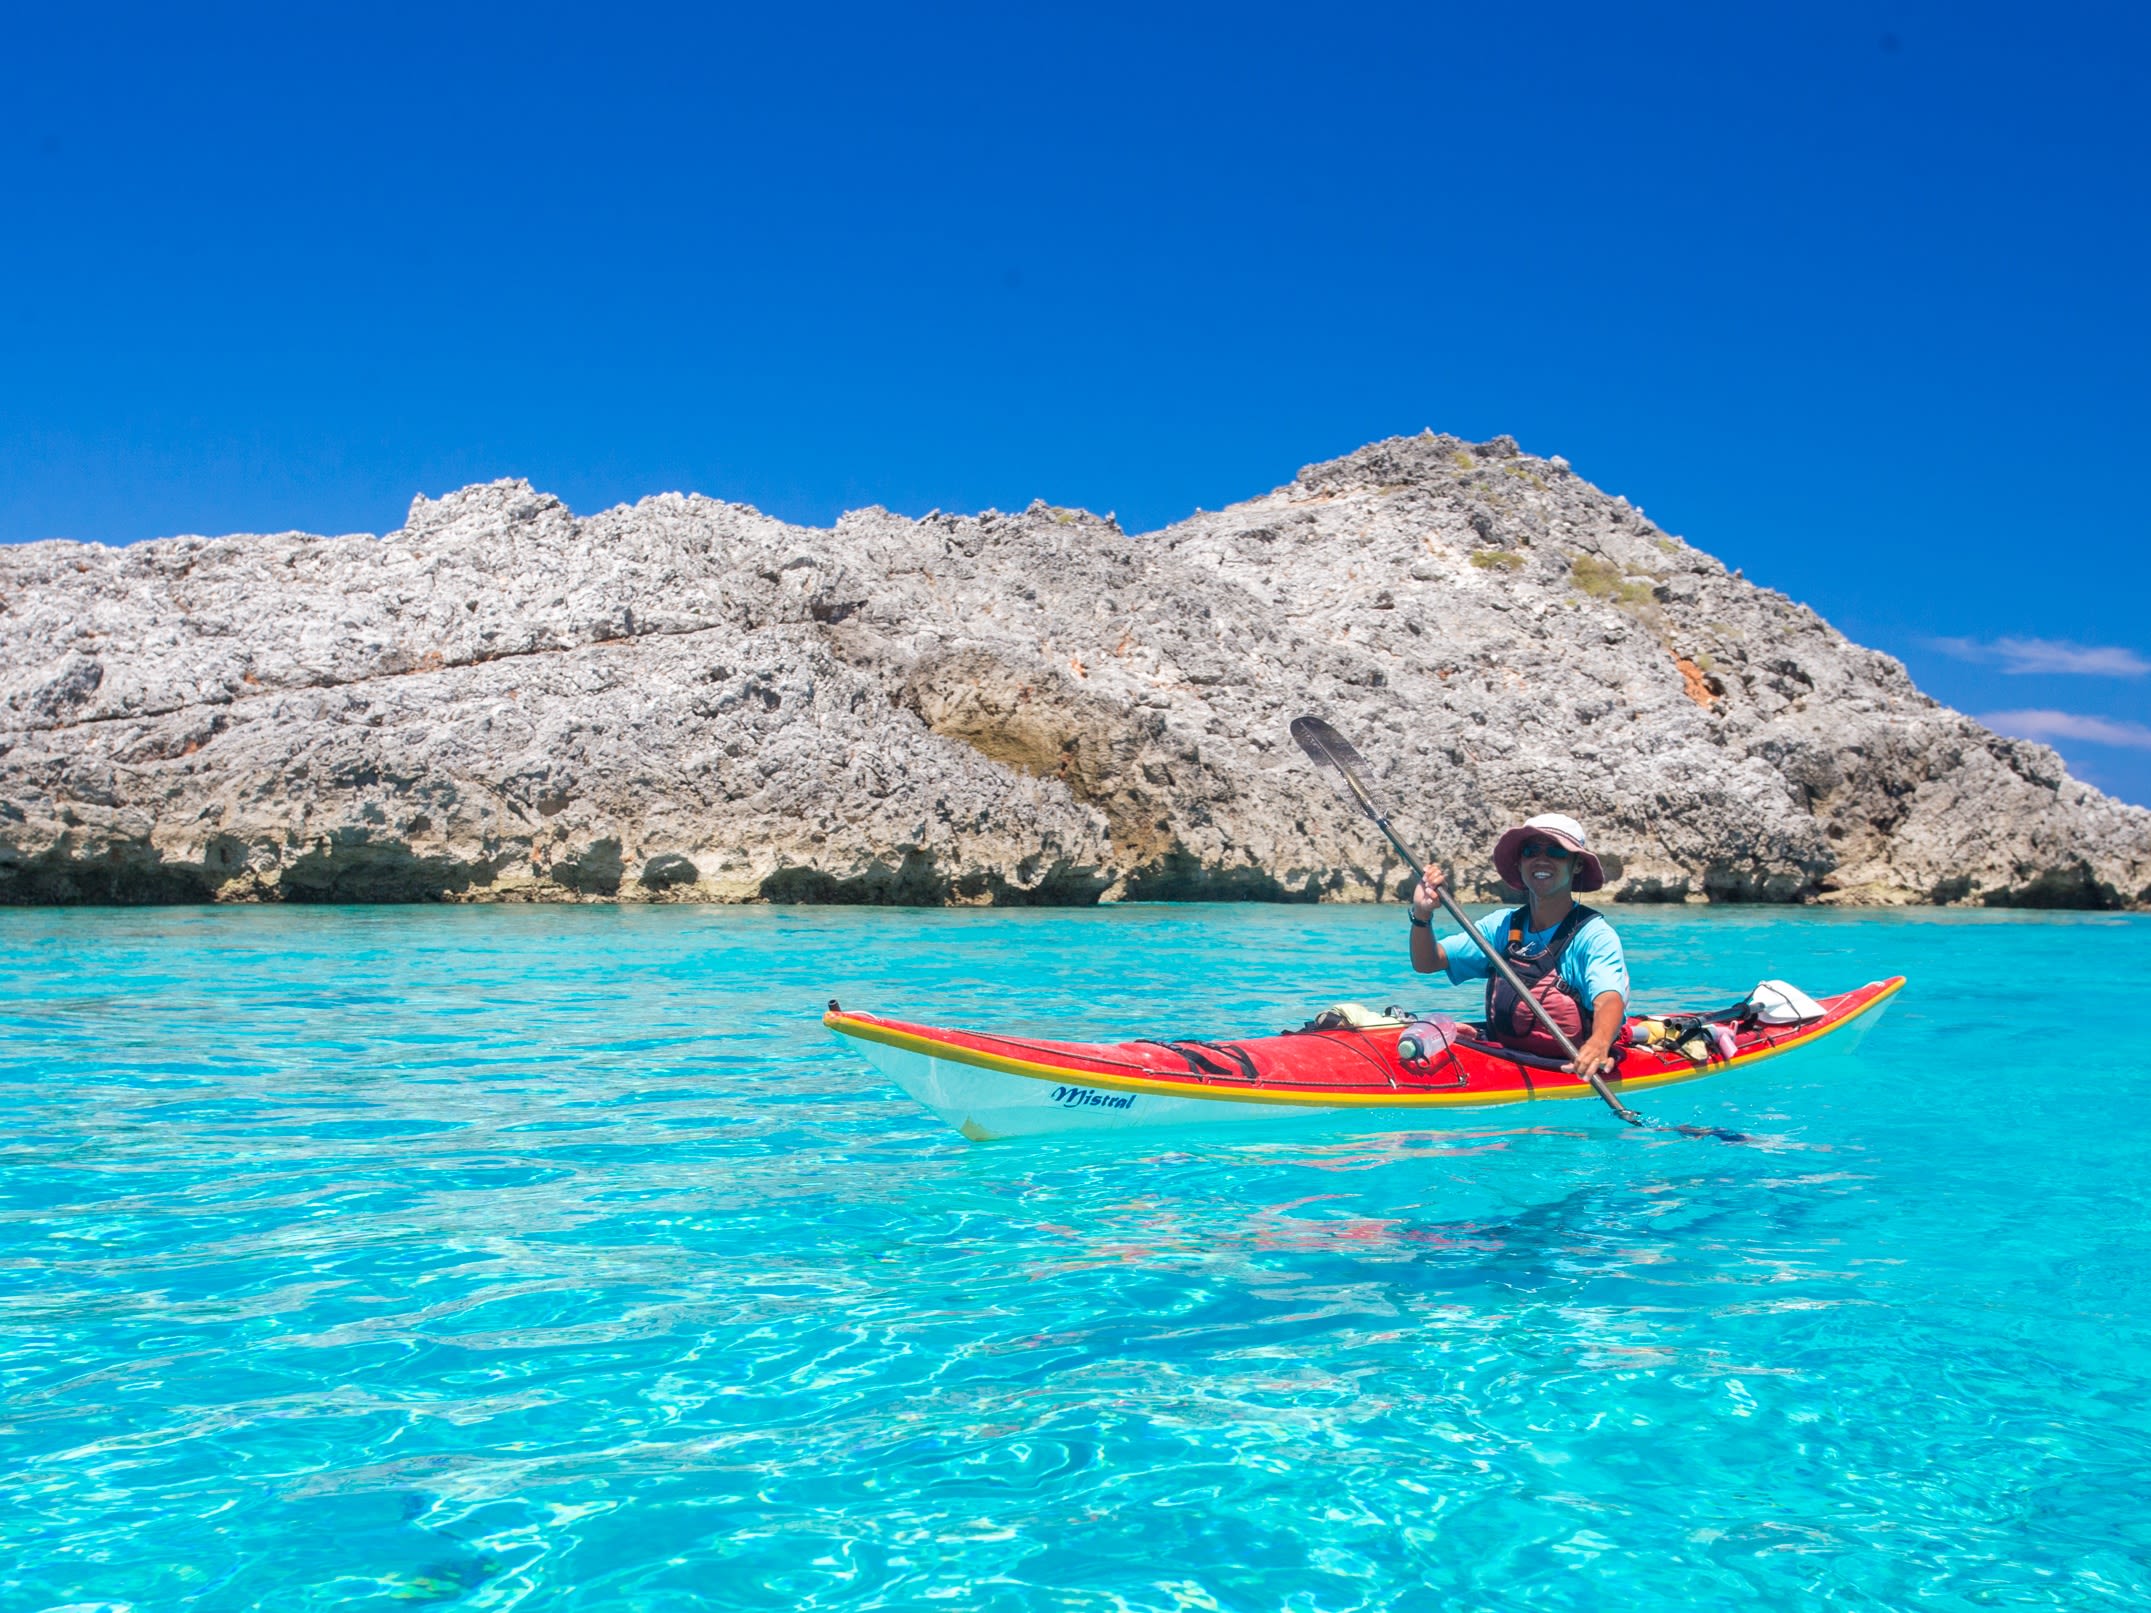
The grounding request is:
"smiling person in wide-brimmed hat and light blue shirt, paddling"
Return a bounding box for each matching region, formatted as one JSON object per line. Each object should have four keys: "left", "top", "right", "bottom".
{"left": 1411, "top": 813, "right": 1628, "bottom": 1073}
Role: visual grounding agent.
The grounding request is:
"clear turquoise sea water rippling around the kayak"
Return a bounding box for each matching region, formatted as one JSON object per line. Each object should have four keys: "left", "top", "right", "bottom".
{"left": 0, "top": 908, "right": 2151, "bottom": 1611}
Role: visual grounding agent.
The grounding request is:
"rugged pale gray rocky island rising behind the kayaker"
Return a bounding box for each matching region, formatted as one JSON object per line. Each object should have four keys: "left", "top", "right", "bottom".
{"left": 0, "top": 434, "right": 2151, "bottom": 905}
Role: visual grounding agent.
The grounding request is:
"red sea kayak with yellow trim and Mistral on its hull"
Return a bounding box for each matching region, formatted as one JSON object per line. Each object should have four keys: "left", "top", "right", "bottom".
{"left": 822, "top": 974, "right": 1904, "bottom": 1142}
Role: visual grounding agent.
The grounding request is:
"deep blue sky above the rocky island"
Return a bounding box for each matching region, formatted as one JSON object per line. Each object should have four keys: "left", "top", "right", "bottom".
{"left": 0, "top": 4, "right": 2151, "bottom": 802}
